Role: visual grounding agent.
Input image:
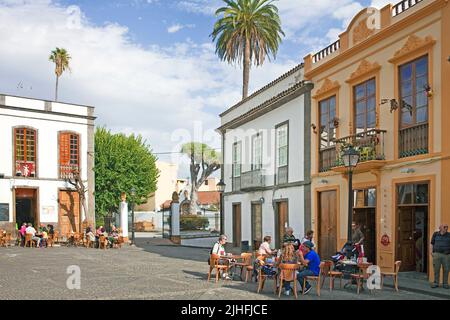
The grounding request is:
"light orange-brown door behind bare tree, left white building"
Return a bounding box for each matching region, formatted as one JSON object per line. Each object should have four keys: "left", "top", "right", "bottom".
{"left": 59, "top": 191, "right": 80, "bottom": 235}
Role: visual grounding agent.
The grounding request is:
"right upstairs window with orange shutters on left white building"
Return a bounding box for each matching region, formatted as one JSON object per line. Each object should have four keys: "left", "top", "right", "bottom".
{"left": 59, "top": 132, "right": 80, "bottom": 178}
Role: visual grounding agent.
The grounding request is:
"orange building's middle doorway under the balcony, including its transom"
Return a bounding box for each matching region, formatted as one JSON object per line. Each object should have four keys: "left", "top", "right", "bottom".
{"left": 353, "top": 188, "right": 377, "bottom": 264}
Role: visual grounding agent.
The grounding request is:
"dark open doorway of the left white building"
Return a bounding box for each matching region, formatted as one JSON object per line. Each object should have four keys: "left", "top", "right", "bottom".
{"left": 15, "top": 189, "right": 39, "bottom": 228}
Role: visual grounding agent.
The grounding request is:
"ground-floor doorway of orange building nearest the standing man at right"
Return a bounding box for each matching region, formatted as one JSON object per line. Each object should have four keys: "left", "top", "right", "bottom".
{"left": 396, "top": 184, "right": 429, "bottom": 273}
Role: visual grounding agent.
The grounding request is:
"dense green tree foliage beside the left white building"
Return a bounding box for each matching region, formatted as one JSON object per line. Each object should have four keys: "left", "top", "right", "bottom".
{"left": 94, "top": 128, "right": 159, "bottom": 221}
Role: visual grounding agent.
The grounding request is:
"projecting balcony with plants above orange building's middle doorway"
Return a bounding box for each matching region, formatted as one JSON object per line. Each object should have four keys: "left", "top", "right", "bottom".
{"left": 323, "top": 129, "right": 387, "bottom": 172}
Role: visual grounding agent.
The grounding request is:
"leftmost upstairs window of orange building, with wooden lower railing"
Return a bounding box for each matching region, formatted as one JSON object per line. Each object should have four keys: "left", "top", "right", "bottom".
{"left": 319, "top": 96, "right": 336, "bottom": 172}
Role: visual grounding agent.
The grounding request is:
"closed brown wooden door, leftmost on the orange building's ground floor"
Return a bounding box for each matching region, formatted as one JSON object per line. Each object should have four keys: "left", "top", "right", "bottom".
{"left": 319, "top": 190, "right": 337, "bottom": 260}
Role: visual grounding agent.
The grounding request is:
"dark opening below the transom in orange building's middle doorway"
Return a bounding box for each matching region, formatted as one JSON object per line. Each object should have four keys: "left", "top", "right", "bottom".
{"left": 353, "top": 208, "right": 376, "bottom": 264}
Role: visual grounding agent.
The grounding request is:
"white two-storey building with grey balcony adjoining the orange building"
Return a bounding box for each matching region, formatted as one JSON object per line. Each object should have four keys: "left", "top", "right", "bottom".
{"left": 218, "top": 65, "right": 312, "bottom": 248}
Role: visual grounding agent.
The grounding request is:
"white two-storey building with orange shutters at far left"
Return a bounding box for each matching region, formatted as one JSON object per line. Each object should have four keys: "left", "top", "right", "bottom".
{"left": 0, "top": 95, "right": 95, "bottom": 235}
